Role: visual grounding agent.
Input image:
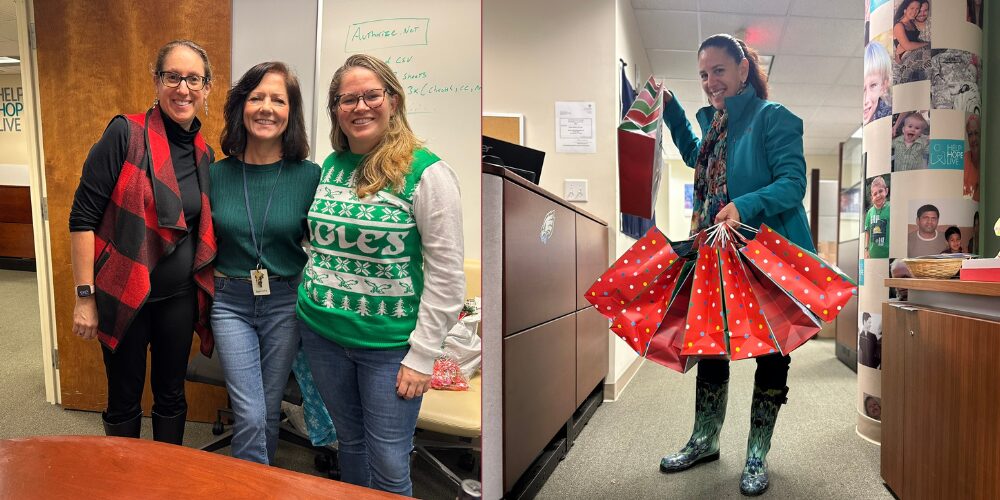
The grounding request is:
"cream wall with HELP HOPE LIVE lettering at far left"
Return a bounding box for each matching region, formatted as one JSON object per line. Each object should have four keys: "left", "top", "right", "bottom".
{"left": 0, "top": 74, "right": 28, "bottom": 186}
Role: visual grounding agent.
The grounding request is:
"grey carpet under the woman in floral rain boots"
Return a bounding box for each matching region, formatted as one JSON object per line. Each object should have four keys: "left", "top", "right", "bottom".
{"left": 538, "top": 340, "right": 892, "bottom": 499}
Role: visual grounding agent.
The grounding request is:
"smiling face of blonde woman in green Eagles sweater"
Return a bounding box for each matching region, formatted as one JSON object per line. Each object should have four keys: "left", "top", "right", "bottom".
{"left": 336, "top": 67, "right": 396, "bottom": 154}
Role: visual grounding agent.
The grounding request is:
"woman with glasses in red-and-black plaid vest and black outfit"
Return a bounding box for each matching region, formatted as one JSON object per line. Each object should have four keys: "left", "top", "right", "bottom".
{"left": 69, "top": 40, "right": 216, "bottom": 444}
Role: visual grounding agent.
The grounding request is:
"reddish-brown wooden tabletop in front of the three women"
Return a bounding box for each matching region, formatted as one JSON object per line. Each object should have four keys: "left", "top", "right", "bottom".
{"left": 0, "top": 436, "right": 402, "bottom": 500}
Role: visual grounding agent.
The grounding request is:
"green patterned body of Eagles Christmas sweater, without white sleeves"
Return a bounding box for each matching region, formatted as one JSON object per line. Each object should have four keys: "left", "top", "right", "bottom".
{"left": 296, "top": 149, "right": 440, "bottom": 349}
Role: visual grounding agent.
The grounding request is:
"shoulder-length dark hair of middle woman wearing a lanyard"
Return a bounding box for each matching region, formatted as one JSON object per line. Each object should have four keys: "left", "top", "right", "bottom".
{"left": 219, "top": 61, "right": 309, "bottom": 161}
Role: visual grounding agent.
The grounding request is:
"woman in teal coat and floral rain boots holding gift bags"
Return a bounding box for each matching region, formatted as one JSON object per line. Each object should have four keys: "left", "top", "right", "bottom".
{"left": 660, "top": 34, "right": 815, "bottom": 496}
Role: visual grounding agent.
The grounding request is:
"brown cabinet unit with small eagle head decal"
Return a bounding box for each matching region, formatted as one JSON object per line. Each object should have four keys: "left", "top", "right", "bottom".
{"left": 483, "top": 165, "right": 609, "bottom": 498}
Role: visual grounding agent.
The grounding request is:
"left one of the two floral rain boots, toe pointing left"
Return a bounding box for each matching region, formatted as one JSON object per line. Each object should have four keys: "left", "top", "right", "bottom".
{"left": 660, "top": 378, "right": 729, "bottom": 472}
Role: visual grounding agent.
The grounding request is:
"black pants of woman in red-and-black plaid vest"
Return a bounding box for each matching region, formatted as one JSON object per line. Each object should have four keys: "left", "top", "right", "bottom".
{"left": 102, "top": 290, "right": 198, "bottom": 424}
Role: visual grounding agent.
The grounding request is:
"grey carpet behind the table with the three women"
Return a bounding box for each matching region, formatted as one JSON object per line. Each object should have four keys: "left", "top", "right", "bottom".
{"left": 0, "top": 269, "right": 471, "bottom": 500}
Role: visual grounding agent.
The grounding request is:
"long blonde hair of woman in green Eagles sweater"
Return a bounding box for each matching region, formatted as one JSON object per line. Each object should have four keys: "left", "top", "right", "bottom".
{"left": 327, "top": 54, "right": 423, "bottom": 198}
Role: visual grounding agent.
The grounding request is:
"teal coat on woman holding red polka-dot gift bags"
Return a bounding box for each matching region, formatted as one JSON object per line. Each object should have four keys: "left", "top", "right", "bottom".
{"left": 663, "top": 89, "right": 815, "bottom": 252}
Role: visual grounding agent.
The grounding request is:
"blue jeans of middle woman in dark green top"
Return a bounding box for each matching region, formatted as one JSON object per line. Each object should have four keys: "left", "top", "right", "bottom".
{"left": 212, "top": 277, "right": 299, "bottom": 464}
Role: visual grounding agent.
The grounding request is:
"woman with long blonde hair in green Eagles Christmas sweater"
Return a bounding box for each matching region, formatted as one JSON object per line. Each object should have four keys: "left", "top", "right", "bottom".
{"left": 297, "top": 54, "right": 465, "bottom": 496}
